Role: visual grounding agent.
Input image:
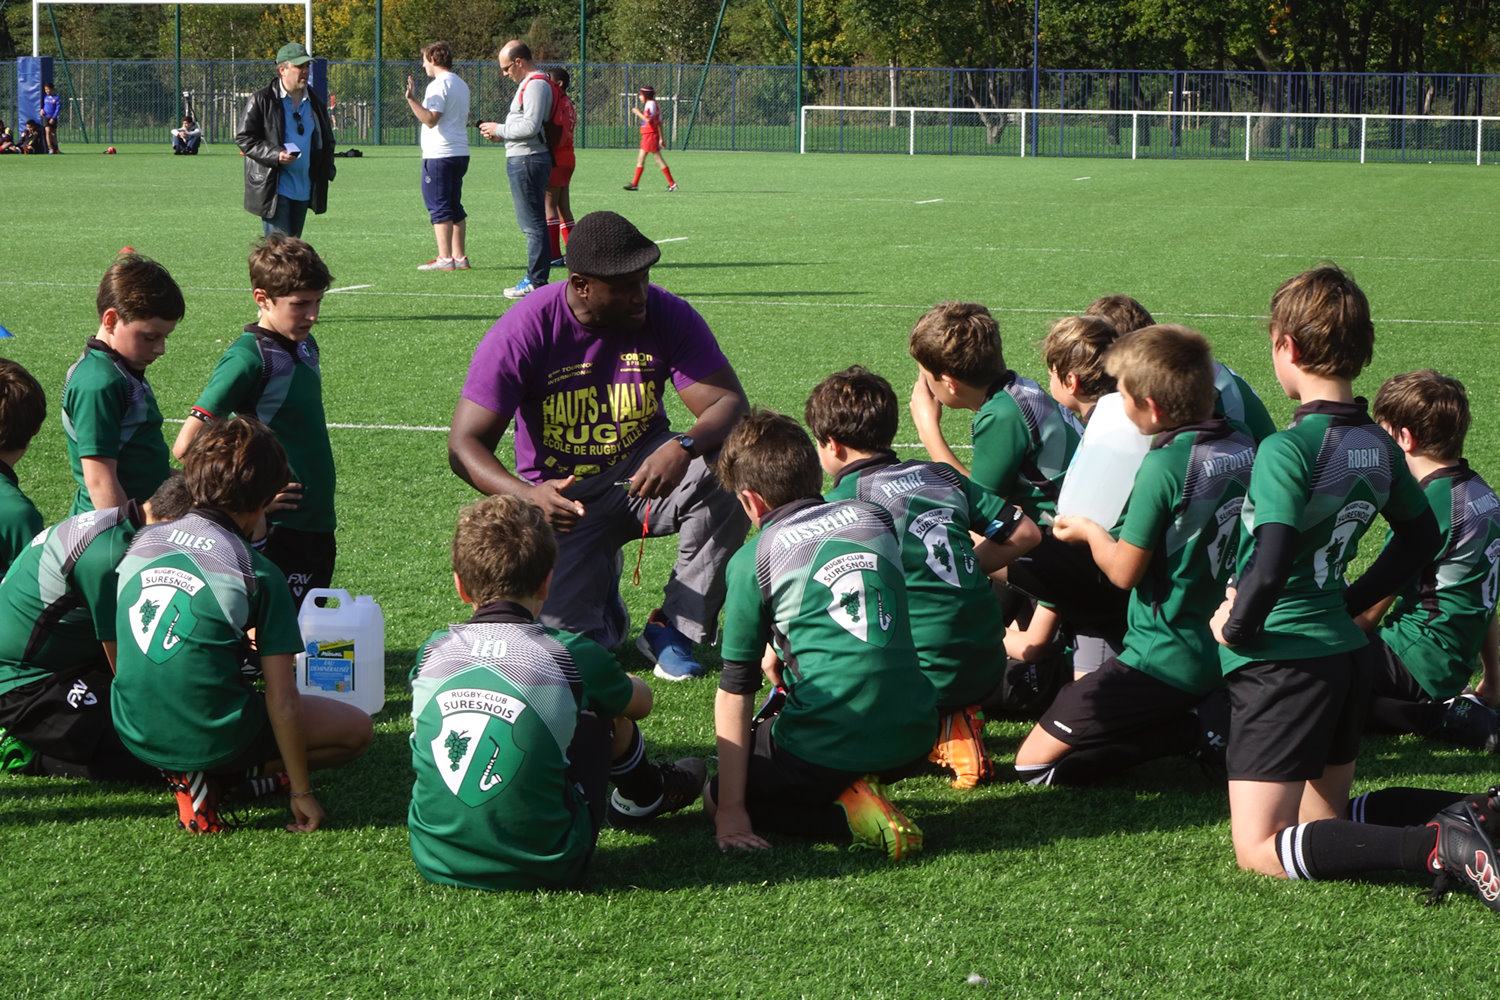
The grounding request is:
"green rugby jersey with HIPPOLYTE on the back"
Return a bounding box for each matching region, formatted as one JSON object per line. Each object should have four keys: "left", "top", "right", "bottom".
{"left": 1119, "top": 418, "right": 1256, "bottom": 694}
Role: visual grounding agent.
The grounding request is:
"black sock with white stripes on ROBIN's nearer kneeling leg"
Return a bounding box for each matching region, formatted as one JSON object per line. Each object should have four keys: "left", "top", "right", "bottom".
{"left": 1277, "top": 820, "right": 1437, "bottom": 879}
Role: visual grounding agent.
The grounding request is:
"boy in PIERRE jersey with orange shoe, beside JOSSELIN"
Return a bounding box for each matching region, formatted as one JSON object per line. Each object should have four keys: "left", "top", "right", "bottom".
{"left": 806, "top": 364, "right": 1041, "bottom": 789}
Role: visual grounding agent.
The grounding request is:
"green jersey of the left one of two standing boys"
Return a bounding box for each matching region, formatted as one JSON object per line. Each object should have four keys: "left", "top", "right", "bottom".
{"left": 63, "top": 337, "right": 173, "bottom": 514}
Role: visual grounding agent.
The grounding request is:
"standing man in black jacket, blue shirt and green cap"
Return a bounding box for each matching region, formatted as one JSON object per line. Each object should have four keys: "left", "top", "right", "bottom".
{"left": 234, "top": 42, "right": 335, "bottom": 237}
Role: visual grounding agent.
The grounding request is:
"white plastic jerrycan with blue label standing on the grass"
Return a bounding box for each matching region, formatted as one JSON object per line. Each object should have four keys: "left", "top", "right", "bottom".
{"left": 297, "top": 589, "right": 386, "bottom": 715}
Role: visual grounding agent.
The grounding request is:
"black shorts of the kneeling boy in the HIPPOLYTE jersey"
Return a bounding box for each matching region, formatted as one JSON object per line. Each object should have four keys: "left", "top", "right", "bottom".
{"left": 1040, "top": 658, "right": 1205, "bottom": 750}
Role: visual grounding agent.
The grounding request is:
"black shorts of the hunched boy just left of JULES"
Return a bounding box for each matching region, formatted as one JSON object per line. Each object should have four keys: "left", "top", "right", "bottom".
{"left": 0, "top": 665, "right": 114, "bottom": 763}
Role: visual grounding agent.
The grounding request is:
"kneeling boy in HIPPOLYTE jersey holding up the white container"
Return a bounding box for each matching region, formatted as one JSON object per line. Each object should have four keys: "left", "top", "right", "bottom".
{"left": 1016, "top": 327, "right": 1256, "bottom": 784}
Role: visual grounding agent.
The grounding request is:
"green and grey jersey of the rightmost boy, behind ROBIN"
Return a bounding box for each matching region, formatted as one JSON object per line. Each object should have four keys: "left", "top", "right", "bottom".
{"left": 1380, "top": 459, "right": 1500, "bottom": 699}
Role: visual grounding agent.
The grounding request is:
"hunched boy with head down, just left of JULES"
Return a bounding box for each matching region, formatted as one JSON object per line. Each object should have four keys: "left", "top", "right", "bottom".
{"left": 0, "top": 472, "right": 192, "bottom": 783}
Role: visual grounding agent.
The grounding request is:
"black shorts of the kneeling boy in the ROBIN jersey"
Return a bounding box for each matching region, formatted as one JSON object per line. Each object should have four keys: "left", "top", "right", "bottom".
{"left": 1227, "top": 651, "right": 1370, "bottom": 781}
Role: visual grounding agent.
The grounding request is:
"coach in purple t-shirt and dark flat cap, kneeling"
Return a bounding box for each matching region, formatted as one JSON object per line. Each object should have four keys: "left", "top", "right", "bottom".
{"left": 449, "top": 211, "right": 749, "bottom": 681}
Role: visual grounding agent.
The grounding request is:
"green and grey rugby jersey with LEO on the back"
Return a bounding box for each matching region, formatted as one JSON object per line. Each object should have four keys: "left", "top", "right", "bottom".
{"left": 407, "top": 601, "right": 632, "bottom": 889}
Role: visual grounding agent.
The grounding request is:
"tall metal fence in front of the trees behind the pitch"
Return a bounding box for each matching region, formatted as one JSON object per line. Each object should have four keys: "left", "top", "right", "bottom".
{"left": 11, "top": 60, "right": 1500, "bottom": 159}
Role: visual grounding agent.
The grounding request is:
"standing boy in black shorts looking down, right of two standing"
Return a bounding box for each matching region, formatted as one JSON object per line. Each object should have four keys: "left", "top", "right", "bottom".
{"left": 173, "top": 232, "right": 338, "bottom": 607}
